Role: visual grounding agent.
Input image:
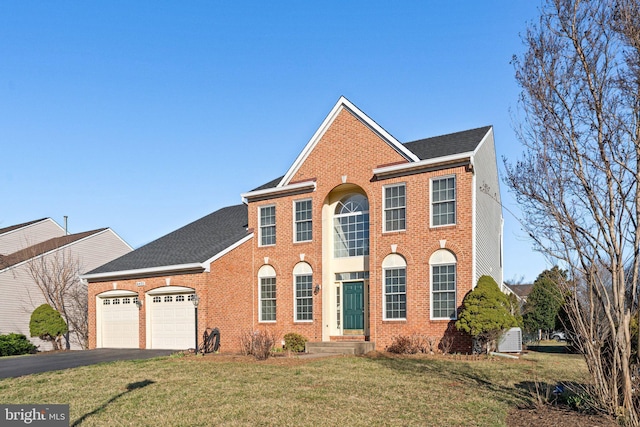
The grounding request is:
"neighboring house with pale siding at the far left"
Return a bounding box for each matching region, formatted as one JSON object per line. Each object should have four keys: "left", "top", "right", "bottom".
{"left": 0, "top": 218, "right": 132, "bottom": 350}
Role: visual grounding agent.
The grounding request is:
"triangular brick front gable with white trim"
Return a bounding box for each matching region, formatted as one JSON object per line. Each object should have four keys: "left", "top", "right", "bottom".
{"left": 277, "top": 97, "right": 419, "bottom": 187}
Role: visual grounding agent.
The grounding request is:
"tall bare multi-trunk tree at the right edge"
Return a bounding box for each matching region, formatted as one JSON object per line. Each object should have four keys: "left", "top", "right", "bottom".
{"left": 505, "top": 0, "right": 640, "bottom": 425}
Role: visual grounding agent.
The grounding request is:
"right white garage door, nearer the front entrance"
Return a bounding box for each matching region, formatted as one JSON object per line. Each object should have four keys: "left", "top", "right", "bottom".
{"left": 151, "top": 294, "right": 196, "bottom": 350}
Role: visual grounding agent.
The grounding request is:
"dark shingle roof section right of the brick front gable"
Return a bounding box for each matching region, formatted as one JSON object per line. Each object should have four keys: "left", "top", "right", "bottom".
{"left": 402, "top": 126, "right": 491, "bottom": 160}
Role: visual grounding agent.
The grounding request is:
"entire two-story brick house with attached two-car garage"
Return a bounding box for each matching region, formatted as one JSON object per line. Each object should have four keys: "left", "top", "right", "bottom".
{"left": 84, "top": 98, "right": 502, "bottom": 351}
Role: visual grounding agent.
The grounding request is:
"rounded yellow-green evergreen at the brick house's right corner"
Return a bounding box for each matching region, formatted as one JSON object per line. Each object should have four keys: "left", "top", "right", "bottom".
{"left": 456, "top": 276, "right": 518, "bottom": 353}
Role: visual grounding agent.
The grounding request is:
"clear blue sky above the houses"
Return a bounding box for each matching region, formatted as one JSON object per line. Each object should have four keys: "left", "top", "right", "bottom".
{"left": 0, "top": 0, "right": 547, "bottom": 281}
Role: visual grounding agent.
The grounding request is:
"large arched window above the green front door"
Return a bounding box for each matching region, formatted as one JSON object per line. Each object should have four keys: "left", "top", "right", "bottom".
{"left": 333, "top": 194, "right": 369, "bottom": 258}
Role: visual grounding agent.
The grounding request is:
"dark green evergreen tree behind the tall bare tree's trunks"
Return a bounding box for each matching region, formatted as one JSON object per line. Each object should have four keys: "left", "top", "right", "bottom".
{"left": 523, "top": 266, "right": 567, "bottom": 337}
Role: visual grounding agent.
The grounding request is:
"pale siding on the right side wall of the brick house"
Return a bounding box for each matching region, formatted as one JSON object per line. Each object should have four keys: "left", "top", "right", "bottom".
{"left": 474, "top": 129, "right": 503, "bottom": 284}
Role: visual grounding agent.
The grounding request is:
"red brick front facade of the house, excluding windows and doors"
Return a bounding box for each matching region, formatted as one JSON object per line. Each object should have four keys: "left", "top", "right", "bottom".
{"left": 89, "top": 99, "right": 490, "bottom": 352}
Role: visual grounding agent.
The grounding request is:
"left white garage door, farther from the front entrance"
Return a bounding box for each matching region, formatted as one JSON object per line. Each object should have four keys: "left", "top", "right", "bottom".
{"left": 101, "top": 297, "right": 139, "bottom": 348}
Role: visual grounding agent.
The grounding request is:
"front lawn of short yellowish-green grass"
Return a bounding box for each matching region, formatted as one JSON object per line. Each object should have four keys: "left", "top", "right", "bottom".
{"left": 0, "top": 353, "right": 587, "bottom": 426}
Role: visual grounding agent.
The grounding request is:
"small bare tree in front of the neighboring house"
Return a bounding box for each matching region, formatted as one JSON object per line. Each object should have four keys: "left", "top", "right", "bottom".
{"left": 27, "top": 250, "right": 89, "bottom": 349}
